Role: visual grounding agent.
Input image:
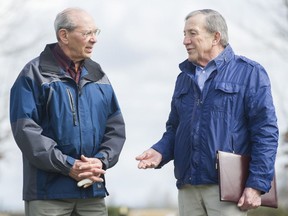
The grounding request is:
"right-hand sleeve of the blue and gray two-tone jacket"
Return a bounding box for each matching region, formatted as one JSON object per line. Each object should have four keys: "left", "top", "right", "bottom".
{"left": 95, "top": 87, "right": 126, "bottom": 169}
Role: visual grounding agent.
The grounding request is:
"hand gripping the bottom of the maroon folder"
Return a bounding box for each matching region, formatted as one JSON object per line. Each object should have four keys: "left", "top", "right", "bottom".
{"left": 237, "top": 188, "right": 261, "bottom": 211}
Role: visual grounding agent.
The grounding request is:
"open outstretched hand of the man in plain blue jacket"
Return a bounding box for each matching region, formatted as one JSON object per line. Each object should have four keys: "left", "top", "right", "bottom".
{"left": 136, "top": 148, "right": 162, "bottom": 169}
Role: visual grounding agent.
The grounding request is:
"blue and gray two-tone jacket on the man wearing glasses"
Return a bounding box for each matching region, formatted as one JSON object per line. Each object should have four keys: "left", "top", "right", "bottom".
{"left": 10, "top": 44, "right": 125, "bottom": 200}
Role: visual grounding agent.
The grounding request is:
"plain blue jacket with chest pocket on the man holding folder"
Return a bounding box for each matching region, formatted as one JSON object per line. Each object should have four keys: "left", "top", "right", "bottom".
{"left": 152, "top": 45, "right": 278, "bottom": 192}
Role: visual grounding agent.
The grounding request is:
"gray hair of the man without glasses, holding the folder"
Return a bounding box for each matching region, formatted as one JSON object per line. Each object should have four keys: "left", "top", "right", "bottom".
{"left": 185, "top": 9, "right": 229, "bottom": 47}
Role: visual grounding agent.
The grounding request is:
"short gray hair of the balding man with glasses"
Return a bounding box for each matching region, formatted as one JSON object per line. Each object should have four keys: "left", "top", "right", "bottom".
{"left": 54, "top": 8, "right": 82, "bottom": 41}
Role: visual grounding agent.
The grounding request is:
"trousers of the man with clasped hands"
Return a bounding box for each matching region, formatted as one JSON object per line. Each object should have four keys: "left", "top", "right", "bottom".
{"left": 25, "top": 198, "right": 108, "bottom": 216}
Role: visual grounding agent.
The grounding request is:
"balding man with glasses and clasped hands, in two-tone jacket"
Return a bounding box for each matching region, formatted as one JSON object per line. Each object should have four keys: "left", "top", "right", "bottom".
{"left": 10, "top": 8, "right": 125, "bottom": 216}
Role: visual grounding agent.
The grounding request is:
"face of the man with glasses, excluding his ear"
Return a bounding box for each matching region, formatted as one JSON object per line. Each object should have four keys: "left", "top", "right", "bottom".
{"left": 67, "top": 12, "right": 99, "bottom": 62}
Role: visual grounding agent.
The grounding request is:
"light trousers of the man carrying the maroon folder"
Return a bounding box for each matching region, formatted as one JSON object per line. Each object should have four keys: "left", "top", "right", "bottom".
{"left": 178, "top": 185, "right": 247, "bottom": 216}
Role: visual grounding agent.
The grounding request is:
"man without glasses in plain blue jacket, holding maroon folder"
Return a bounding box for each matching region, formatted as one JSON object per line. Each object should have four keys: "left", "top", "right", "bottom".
{"left": 136, "top": 9, "right": 278, "bottom": 216}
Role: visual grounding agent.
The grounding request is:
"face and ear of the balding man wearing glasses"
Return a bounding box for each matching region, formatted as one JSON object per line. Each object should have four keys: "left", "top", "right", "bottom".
{"left": 59, "top": 10, "right": 99, "bottom": 64}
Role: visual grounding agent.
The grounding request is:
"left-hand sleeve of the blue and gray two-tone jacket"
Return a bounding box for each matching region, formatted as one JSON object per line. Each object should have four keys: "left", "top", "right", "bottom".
{"left": 10, "top": 64, "right": 74, "bottom": 175}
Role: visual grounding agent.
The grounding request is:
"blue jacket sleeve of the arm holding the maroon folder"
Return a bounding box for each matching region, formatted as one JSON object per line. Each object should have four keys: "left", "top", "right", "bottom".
{"left": 246, "top": 65, "right": 278, "bottom": 192}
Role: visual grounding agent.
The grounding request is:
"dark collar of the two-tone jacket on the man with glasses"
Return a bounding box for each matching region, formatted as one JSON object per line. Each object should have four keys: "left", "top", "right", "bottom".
{"left": 39, "top": 43, "right": 105, "bottom": 82}
